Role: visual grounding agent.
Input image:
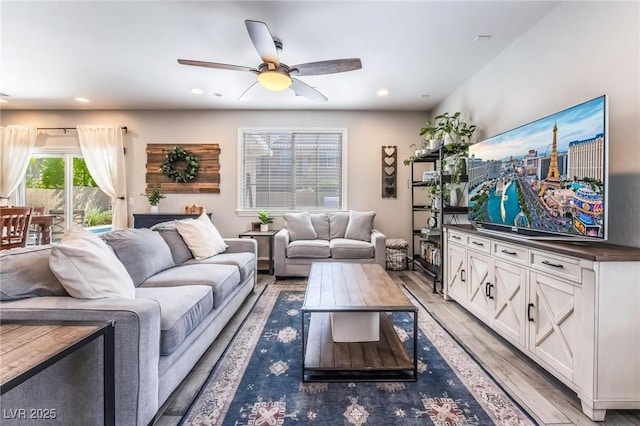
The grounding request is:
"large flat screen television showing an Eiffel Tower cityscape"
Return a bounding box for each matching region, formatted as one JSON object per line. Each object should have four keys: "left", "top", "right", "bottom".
{"left": 468, "top": 95, "right": 608, "bottom": 241}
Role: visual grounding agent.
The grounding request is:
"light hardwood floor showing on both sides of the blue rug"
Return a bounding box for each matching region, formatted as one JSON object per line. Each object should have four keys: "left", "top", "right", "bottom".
{"left": 155, "top": 271, "right": 640, "bottom": 426}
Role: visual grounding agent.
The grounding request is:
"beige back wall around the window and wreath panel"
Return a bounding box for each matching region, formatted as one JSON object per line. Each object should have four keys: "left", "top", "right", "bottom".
{"left": 1, "top": 110, "right": 426, "bottom": 240}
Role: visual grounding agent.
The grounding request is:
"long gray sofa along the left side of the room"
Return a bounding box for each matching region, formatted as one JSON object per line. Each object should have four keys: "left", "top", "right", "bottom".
{"left": 0, "top": 222, "right": 257, "bottom": 426}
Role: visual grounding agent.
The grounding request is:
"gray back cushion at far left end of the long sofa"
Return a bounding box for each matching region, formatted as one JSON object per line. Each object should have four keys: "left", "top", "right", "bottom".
{"left": 0, "top": 245, "right": 69, "bottom": 300}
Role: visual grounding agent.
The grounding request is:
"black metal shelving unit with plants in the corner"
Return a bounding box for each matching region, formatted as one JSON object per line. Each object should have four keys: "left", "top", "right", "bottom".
{"left": 409, "top": 146, "right": 468, "bottom": 293}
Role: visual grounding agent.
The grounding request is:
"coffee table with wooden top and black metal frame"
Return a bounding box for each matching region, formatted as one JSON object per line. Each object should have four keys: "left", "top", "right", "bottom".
{"left": 301, "top": 262, "right": 418, "bottom": 382}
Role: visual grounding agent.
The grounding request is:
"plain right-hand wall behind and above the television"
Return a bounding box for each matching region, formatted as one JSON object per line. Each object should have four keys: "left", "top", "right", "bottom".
{"left": 437, "top": 1, "right": 640, "bottom": 247}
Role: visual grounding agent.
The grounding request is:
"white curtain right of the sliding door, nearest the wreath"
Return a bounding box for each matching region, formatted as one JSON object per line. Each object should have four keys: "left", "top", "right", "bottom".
{"left": 77, "top": 125, "right": 128, "bottom": 229}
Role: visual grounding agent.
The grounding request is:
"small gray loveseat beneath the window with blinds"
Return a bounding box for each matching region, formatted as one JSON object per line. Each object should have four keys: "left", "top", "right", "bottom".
{"left": 273, "top": 211, "right": 386, "bottom": 277}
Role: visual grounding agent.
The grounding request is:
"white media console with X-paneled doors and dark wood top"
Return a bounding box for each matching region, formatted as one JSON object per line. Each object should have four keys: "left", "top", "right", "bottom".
{"left": 443, "top": 225, "right": 640, "bottom": 421}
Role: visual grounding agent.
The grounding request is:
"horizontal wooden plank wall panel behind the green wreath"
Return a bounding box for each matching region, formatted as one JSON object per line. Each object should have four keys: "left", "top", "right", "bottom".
{"left": 146, "top": 143, "right": 220, "bottom": 194}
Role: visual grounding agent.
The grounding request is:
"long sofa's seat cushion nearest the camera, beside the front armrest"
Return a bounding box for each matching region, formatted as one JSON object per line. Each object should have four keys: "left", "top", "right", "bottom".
{"left": 136, "top": 285, "right": 213, "bottom": 355}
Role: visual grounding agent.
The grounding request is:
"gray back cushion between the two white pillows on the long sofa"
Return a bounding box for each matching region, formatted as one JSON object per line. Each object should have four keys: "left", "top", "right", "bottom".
{"left": 101, "top": 228, "right": 175, "bottom": 287}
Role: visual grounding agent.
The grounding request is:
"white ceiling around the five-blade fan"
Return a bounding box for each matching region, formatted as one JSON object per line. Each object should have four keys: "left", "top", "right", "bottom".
{"left": 0, "top": 0, "right": 558, "bottom": 111}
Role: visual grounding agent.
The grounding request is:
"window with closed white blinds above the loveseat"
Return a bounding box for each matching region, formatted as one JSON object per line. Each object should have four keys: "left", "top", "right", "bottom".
{"left": 239, "top": 129, "right": 346, "bottom": 211}
